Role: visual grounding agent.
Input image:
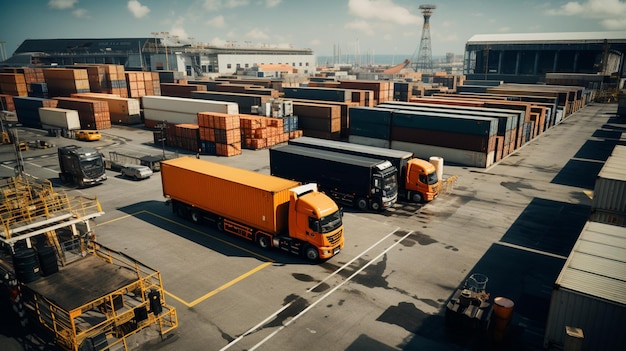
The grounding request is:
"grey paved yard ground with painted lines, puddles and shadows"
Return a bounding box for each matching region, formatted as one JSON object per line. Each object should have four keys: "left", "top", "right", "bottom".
{"left": 0, "top": 104, "right": 626, "bottom": 351}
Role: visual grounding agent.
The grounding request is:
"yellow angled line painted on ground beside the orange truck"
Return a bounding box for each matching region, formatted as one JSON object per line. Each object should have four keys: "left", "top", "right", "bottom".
{"left": 97, "top": 210, "right": 274, "bottom": 307}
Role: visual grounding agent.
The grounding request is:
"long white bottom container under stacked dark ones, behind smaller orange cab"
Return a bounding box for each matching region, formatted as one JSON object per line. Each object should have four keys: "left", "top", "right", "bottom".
{"left": 391, "top": 140, "right": 494, "bottom": 168}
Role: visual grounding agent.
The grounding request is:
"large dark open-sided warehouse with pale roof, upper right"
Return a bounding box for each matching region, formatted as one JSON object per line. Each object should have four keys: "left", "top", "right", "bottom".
{"left": 463, "top": 31, "right": 626, "bottom": 86}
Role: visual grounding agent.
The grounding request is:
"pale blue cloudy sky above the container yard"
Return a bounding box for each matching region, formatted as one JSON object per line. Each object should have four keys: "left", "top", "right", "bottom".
{"left": 0, "top": 0, "right": 626, "bottom": 58}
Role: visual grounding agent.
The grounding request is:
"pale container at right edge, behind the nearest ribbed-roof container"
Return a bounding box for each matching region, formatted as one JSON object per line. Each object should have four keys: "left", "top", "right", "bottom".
{"left": 591, "top": 145, "right": 626, "bottom": 215}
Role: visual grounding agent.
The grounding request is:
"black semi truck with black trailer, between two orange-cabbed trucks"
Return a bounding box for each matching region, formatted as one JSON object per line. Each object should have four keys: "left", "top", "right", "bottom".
{"left": 270, "top": 145, "right": 398, "bottom": 211}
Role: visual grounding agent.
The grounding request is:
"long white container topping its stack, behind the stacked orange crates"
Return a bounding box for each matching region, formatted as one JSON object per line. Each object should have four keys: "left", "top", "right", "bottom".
{"left": 141, "top": 96, "right": 239, "bottom": 115}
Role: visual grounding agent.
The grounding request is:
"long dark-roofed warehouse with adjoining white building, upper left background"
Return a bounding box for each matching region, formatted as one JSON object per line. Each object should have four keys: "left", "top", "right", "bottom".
{"left": 0, "top": 37, "right": 316, "bottom": 79}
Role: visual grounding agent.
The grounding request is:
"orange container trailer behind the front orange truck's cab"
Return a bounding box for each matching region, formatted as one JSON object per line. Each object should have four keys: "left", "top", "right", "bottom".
{"left": 161, "top": 157, "right": 299, "bottom": 233}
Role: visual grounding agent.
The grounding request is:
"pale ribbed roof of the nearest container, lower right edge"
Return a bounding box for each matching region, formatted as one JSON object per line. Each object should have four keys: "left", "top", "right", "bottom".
{"left": 556, "top": 222, "right": 626, "bottom": 306}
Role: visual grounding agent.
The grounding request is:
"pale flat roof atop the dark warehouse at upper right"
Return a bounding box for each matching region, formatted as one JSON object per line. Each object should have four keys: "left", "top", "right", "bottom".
{"left": 467, "top": 31, "right": 626, "bottom": 44}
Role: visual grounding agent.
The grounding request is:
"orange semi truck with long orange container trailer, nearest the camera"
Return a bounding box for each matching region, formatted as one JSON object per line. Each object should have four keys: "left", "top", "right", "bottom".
{"left": 161, "top": 157, "right": 344, "bottom": 261}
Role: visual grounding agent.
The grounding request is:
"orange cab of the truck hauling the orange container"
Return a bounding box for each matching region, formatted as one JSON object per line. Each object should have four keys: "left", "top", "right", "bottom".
{"left": 286, "top": 183, "right": 344, "bottom": 261}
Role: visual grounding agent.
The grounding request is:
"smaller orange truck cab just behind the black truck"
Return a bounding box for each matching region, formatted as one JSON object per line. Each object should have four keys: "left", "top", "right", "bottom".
{"left": 405, "top": 158, "right": 440, "bottom": 202}
